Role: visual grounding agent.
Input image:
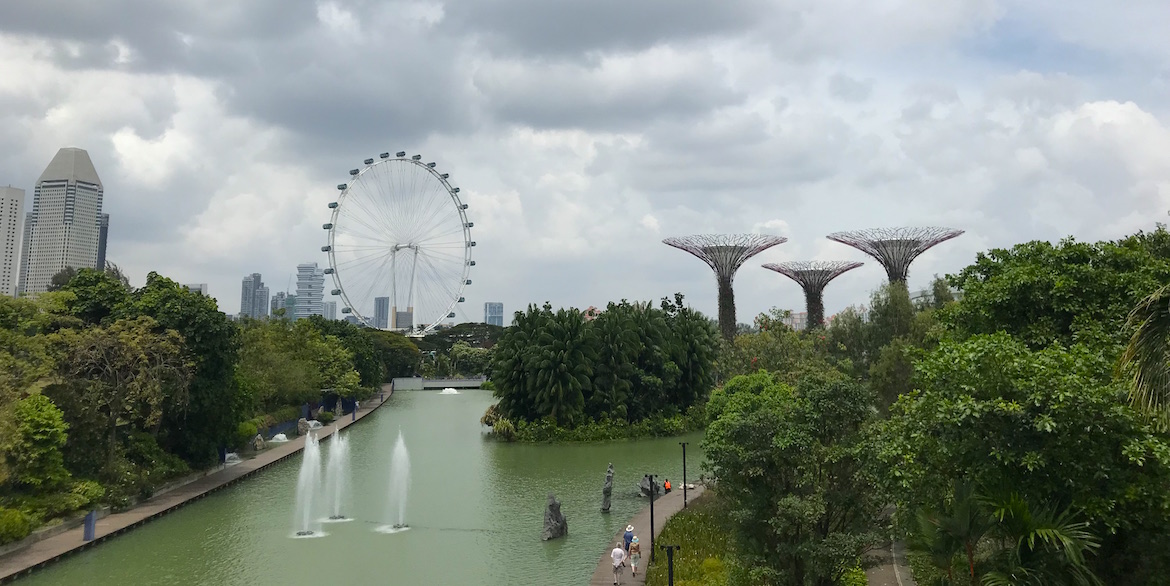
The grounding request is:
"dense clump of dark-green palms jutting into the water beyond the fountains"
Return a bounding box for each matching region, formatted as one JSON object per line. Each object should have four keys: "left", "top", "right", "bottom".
{"left": 490, "top": 295, "right": 718, "bottom": 435}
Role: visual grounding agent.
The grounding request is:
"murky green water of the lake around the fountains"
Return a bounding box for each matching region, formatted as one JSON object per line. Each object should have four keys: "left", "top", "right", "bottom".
{"left": 16, "top": 391, "right": 701, "bottom": 586}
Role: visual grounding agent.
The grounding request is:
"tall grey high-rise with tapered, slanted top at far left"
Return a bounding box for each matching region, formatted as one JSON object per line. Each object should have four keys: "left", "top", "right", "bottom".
{"left": 20, "top": 149, "right": 104, "bottom": 295}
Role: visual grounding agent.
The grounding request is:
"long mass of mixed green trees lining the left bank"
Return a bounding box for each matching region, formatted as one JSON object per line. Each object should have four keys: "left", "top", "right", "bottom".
{"left": 0, "top": 266, "right": 419, "bottom": 543}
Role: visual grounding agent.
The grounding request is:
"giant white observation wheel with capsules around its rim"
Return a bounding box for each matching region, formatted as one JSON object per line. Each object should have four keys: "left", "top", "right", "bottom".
{"left": 321, "top": 152, "right": 475, "bottom": 333}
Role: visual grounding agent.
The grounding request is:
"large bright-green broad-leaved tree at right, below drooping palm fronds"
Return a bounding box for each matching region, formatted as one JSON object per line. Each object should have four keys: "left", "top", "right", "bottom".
{"left": 879, "top": 334, "right": 1170, "bottom": 584}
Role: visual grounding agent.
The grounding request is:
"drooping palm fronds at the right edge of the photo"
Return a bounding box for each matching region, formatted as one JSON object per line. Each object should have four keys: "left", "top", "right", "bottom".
{"left": 1121, "top": 285, "right": 1170, "bottom": 429}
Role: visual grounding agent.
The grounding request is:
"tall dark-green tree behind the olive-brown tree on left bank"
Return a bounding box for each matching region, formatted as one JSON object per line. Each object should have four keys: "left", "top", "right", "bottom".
{"left": 125, "top": 273, "right": 238, "bottom": 464}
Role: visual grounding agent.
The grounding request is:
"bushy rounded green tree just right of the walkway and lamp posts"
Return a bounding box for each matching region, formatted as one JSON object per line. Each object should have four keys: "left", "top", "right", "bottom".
{"left": 703, "top": 371, "right": 883, "bottom": 586}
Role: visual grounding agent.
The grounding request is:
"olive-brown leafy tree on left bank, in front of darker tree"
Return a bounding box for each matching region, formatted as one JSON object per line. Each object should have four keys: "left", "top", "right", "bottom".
{"left": 56, "top": 317, "right": 191, "bottom": 463}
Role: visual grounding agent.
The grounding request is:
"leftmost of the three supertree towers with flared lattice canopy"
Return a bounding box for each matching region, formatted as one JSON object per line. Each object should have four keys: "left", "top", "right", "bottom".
{"left": 662, "top": 234, "right": 789, "bottom": 342}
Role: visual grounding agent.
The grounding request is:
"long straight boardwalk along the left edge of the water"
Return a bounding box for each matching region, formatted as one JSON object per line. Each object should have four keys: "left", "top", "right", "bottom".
{"left": 0, "top": 391, "right": 393, "bottom": 582}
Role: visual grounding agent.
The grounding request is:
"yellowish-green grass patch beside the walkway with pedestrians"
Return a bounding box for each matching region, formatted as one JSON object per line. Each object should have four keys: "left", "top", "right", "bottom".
{"left": 642, "top": 491, "right": 731, "bottom": 586}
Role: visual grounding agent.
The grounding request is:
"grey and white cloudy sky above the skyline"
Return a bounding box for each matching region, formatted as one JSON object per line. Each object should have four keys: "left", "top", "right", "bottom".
{"left": 0, "top": 0, "right": 1170, "bottom": 322}
